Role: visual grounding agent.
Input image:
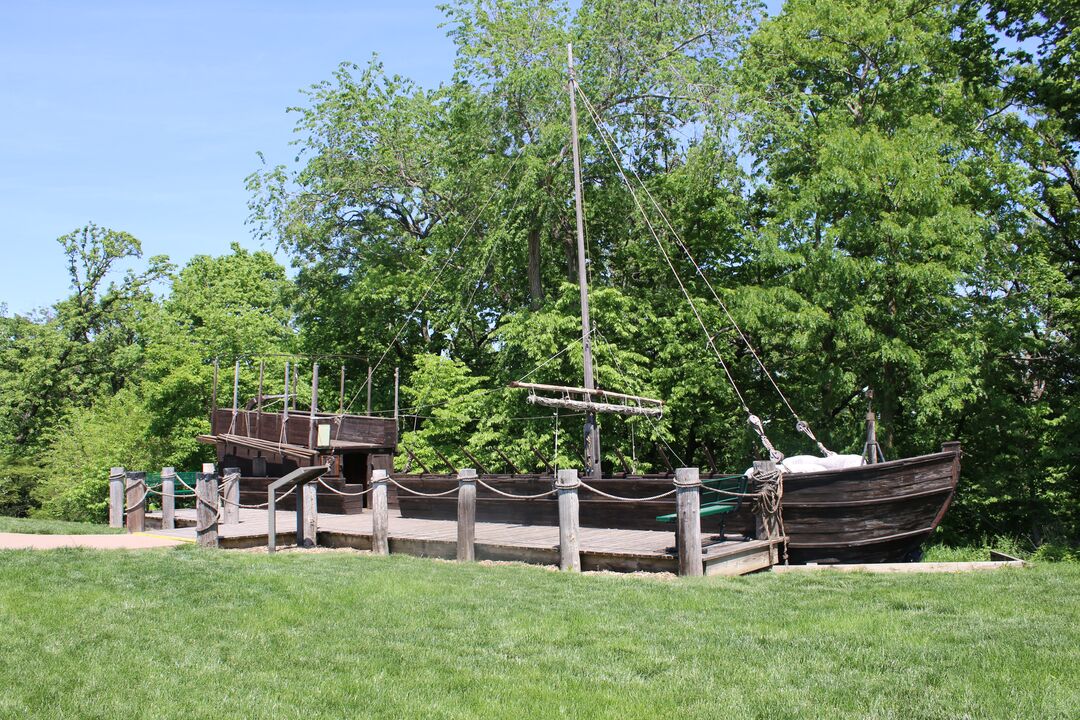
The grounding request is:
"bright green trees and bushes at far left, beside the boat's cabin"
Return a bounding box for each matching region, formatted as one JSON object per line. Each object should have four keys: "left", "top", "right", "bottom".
{"left": 0, "top": 234, "right": 293, "bottom": 521}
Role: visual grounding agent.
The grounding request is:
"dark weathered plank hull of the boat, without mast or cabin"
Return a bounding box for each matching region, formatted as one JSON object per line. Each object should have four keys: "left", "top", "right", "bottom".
{"left": 397, "top": 444, "right": 960, "bottom": 563}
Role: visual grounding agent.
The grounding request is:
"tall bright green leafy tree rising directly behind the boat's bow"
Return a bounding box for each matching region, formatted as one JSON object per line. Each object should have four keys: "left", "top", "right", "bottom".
{"left": 743, "top": 0, "right": 996, "bottom": 454}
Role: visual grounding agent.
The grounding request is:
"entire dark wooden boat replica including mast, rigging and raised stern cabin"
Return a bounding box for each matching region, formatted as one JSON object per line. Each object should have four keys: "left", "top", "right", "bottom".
{"left": 200, "top": 43, "right": 960, "bottom": 563}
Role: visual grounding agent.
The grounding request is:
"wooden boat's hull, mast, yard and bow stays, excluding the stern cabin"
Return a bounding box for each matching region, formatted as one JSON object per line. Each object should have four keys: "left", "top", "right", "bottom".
{"left": 390, "top": 49, "right": 960, "bottom": 563}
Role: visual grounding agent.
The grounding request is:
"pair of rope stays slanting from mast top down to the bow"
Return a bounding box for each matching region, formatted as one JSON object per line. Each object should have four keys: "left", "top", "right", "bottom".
{"left": 577, "top": 85, "right": 836, "bottom": 455}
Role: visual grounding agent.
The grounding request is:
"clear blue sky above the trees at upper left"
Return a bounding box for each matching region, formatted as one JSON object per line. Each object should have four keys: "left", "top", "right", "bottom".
{"left": 0, "top": 0, "right": 454, "bottom": 313}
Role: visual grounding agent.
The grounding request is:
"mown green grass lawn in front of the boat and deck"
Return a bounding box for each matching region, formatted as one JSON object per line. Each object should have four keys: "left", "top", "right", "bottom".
{"left": 0, "top": 546, "right": 1080, "bottom": 720}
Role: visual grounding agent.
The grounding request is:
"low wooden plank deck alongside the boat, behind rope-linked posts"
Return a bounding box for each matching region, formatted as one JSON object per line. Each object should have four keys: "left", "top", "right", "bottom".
{"left": 147, "top": 510, "right": 781, "bottom": 575}
